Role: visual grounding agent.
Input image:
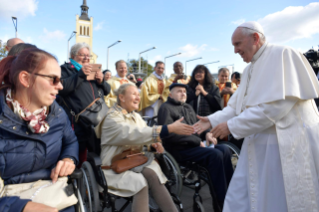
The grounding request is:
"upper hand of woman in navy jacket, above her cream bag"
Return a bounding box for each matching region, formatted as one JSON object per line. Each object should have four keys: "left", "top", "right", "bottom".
{"left": 50, "top": 158, "right": 75, "bottom": 183}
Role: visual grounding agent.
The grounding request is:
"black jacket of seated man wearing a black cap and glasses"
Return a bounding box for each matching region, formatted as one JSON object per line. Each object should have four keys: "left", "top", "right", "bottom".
{"left": 158, "top": 97, "right": 206, "bottom": 152}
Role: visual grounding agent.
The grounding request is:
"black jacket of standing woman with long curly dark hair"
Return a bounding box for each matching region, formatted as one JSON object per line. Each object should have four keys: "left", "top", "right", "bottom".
{"left": 186, "top": 84, "right": 221, "bottom": 116}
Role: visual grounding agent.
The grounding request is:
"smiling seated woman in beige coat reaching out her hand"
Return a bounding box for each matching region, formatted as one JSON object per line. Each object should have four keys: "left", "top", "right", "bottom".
{"left": 96, "top": 84, "right": 193, "bottom": 212}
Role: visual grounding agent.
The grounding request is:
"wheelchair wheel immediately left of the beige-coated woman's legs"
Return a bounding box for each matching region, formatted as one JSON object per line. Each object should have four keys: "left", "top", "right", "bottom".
{"left": 81, "top": 161, "right": 100, "bottom": 212}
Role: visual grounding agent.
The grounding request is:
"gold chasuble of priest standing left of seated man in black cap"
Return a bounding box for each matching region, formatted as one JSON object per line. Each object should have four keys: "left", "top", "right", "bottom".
{"left": 139, "top": 74, "right": 169, "bottom": 111}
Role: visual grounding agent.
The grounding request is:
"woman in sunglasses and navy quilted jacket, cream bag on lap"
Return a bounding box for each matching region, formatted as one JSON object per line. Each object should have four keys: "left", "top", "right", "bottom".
{"left": 0, "top": 48, "right": 78, "bottom": 212}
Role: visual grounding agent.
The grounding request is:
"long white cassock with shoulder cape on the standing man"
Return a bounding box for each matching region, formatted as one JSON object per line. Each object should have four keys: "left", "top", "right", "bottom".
{"left": 208, "top": 43, "right": 319, "bottom": 212}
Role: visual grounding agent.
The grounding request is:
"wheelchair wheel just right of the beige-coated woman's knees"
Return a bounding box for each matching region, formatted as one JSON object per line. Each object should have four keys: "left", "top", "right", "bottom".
{"left": 164, "top": 152, "right": 183, "bottom": 197}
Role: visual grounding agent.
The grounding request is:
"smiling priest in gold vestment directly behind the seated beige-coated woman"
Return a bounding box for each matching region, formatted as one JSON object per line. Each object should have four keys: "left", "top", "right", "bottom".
{"left": 104, "top": 60, "right": 135, "bottom": 108}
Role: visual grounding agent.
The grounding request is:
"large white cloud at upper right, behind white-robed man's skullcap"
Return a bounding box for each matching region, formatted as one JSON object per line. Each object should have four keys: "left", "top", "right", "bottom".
{"left": 258, "top": 2, "right": 319, "bottom": 43}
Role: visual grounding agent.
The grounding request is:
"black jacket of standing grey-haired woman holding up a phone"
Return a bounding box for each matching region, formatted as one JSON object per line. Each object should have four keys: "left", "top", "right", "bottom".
{"left": 58, "top": 63, "right": 111, "bottom": 151}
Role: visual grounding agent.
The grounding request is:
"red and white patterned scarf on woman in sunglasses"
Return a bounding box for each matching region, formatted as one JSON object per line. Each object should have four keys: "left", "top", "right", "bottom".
{"left": 6, "top": 88, "right": 50, "bottom": 133}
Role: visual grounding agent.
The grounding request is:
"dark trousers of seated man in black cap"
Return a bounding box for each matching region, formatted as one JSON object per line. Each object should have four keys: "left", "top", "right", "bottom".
{"left": 169, "top": 145, "right": 234, "bottom": 202}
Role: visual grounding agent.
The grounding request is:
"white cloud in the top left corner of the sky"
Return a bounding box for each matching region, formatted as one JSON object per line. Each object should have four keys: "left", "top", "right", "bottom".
{"left": 0, "top": 0, "right": 39, "bottom": 21}
